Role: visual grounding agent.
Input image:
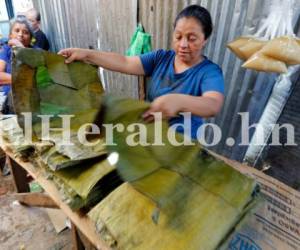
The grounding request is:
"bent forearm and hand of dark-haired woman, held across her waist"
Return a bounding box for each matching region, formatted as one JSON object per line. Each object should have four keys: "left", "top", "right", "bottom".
{"left": 144, "top": 91, "right": 224, "bottom": 121}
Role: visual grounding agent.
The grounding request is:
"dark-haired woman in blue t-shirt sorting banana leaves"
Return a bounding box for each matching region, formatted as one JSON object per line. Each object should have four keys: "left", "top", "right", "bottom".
{"left": 59, "top": 5, "right": 224, "bottom": 138}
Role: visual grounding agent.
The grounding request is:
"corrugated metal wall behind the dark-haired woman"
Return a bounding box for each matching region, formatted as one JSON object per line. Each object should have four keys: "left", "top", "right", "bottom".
{"left": 34, "top": 0, "right": 300, "bottom": 161}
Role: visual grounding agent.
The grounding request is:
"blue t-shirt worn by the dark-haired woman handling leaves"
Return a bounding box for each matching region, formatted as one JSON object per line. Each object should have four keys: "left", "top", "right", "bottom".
{"left": 140, "top": 49, "right": 224, "bottom": 139}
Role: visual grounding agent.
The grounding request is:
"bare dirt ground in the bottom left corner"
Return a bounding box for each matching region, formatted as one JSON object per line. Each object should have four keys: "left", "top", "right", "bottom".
{"left": 0, "top": 174, "right": 72, "bottom": 250}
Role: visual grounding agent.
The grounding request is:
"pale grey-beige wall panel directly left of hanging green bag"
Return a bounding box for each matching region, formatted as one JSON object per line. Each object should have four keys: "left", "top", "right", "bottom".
{"left": 99, "top": 0, "right": 138, "bottom": 98}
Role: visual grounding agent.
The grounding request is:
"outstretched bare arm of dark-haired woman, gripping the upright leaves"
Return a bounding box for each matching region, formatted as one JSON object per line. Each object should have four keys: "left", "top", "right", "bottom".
{"left": 58, "top": 48, "right": 145, "bottom": 75}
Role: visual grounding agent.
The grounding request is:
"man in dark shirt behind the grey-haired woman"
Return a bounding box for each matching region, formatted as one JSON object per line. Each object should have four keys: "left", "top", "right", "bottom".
{"left": 26, "top": 9, "right": 50, "bottom": 50}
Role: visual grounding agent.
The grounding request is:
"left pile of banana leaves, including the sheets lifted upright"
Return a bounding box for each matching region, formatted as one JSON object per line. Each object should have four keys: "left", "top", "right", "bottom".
{"left": 10, "top": 49, "right": 121, "bottom": 210}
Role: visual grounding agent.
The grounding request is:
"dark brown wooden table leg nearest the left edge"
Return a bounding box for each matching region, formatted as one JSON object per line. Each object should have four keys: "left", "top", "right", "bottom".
{"left": 6, "top": 154, "right": 30, "bottom": 193}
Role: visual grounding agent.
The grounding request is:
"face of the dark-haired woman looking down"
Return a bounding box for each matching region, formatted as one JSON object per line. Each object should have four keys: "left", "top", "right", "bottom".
{"left": 173, "top": 17, "right": 207, "bottom": 65}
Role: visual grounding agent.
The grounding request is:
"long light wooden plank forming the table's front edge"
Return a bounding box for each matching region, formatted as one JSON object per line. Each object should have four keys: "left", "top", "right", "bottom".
{"left": 1, "top": 145, "right": 110, "bottom": 250}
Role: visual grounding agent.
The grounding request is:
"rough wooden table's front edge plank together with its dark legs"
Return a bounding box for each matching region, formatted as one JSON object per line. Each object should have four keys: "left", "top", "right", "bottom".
{"left": 0, "top": 145, "right": 110, "bottom": 250}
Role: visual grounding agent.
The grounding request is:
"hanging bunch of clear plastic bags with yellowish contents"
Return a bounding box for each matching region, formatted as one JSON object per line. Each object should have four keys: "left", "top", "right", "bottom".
{"left": 227, "top": 0, "right": 300, "bottom": 73}
